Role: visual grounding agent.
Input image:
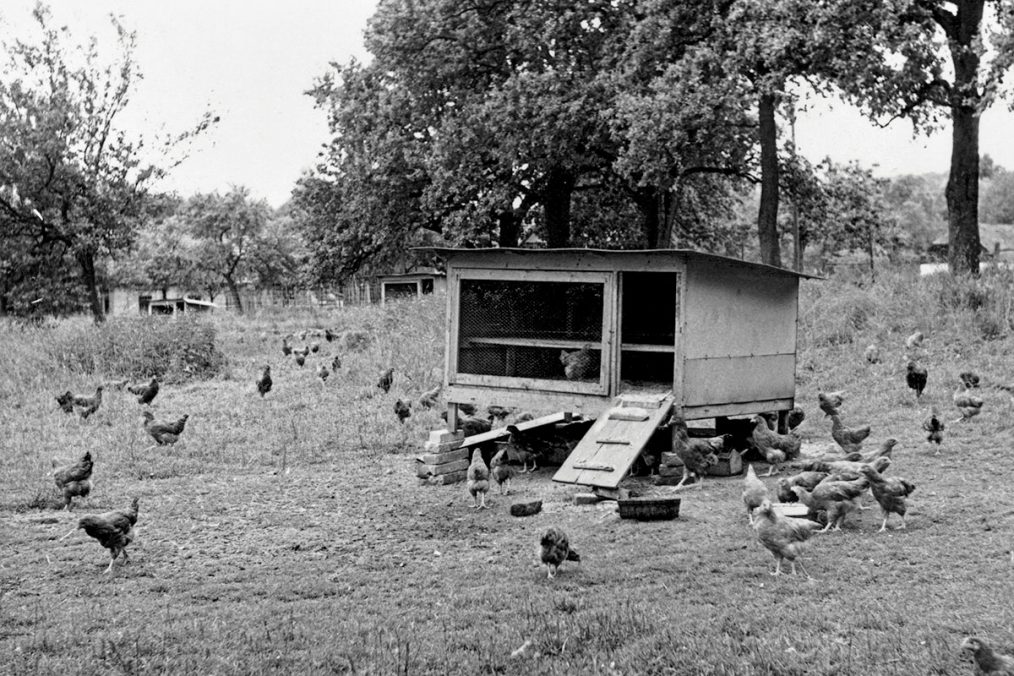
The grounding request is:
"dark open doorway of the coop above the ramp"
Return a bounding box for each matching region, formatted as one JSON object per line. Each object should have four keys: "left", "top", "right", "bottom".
{"left": 618, "top": 272, "right": 679, "bottom": 394}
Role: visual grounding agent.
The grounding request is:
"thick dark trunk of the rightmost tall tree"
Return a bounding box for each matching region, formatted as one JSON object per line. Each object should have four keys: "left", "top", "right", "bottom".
{"left": 941, "top": 0, "right": 985, "bottom": 275}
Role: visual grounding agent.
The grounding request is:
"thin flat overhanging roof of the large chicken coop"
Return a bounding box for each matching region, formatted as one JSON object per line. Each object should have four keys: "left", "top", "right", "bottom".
{"left": 420, "top": 247, "right": 823, "bottom": 280}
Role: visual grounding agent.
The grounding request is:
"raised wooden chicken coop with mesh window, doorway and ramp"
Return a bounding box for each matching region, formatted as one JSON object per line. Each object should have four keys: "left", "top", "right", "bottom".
{"left": 427, "top": 248, "right": 805, "bottom": 487}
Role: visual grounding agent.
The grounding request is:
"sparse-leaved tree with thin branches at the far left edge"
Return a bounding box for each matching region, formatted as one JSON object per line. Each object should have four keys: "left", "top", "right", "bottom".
{"left": 0, "top": 4, "right": 213, "bottom": 321}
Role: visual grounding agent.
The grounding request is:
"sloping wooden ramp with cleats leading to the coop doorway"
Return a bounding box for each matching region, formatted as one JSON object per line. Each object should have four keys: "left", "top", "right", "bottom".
{"left": 553, "top": 393, "right": 673, "bottom": 490}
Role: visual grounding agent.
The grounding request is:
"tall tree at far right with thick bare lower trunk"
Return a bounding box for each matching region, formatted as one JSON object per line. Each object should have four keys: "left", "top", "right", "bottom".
{"left": 842, "top": 0, "right": 1014, "bottom": 275}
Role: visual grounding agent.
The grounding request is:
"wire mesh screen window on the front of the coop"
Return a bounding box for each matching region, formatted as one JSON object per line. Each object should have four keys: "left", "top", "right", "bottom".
{"left": 457, "top": 280, "right": 603, "bottom": 382}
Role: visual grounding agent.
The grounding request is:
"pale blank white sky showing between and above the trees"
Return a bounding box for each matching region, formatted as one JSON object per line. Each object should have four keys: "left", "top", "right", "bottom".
{"left": 0, "top": 0, "right": 1014, "bottom": 207}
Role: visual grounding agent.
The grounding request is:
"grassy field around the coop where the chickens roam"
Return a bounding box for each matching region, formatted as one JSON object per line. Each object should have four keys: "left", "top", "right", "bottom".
{"left": 0, "top": 271, "right": 1014, "bottom": 675}
